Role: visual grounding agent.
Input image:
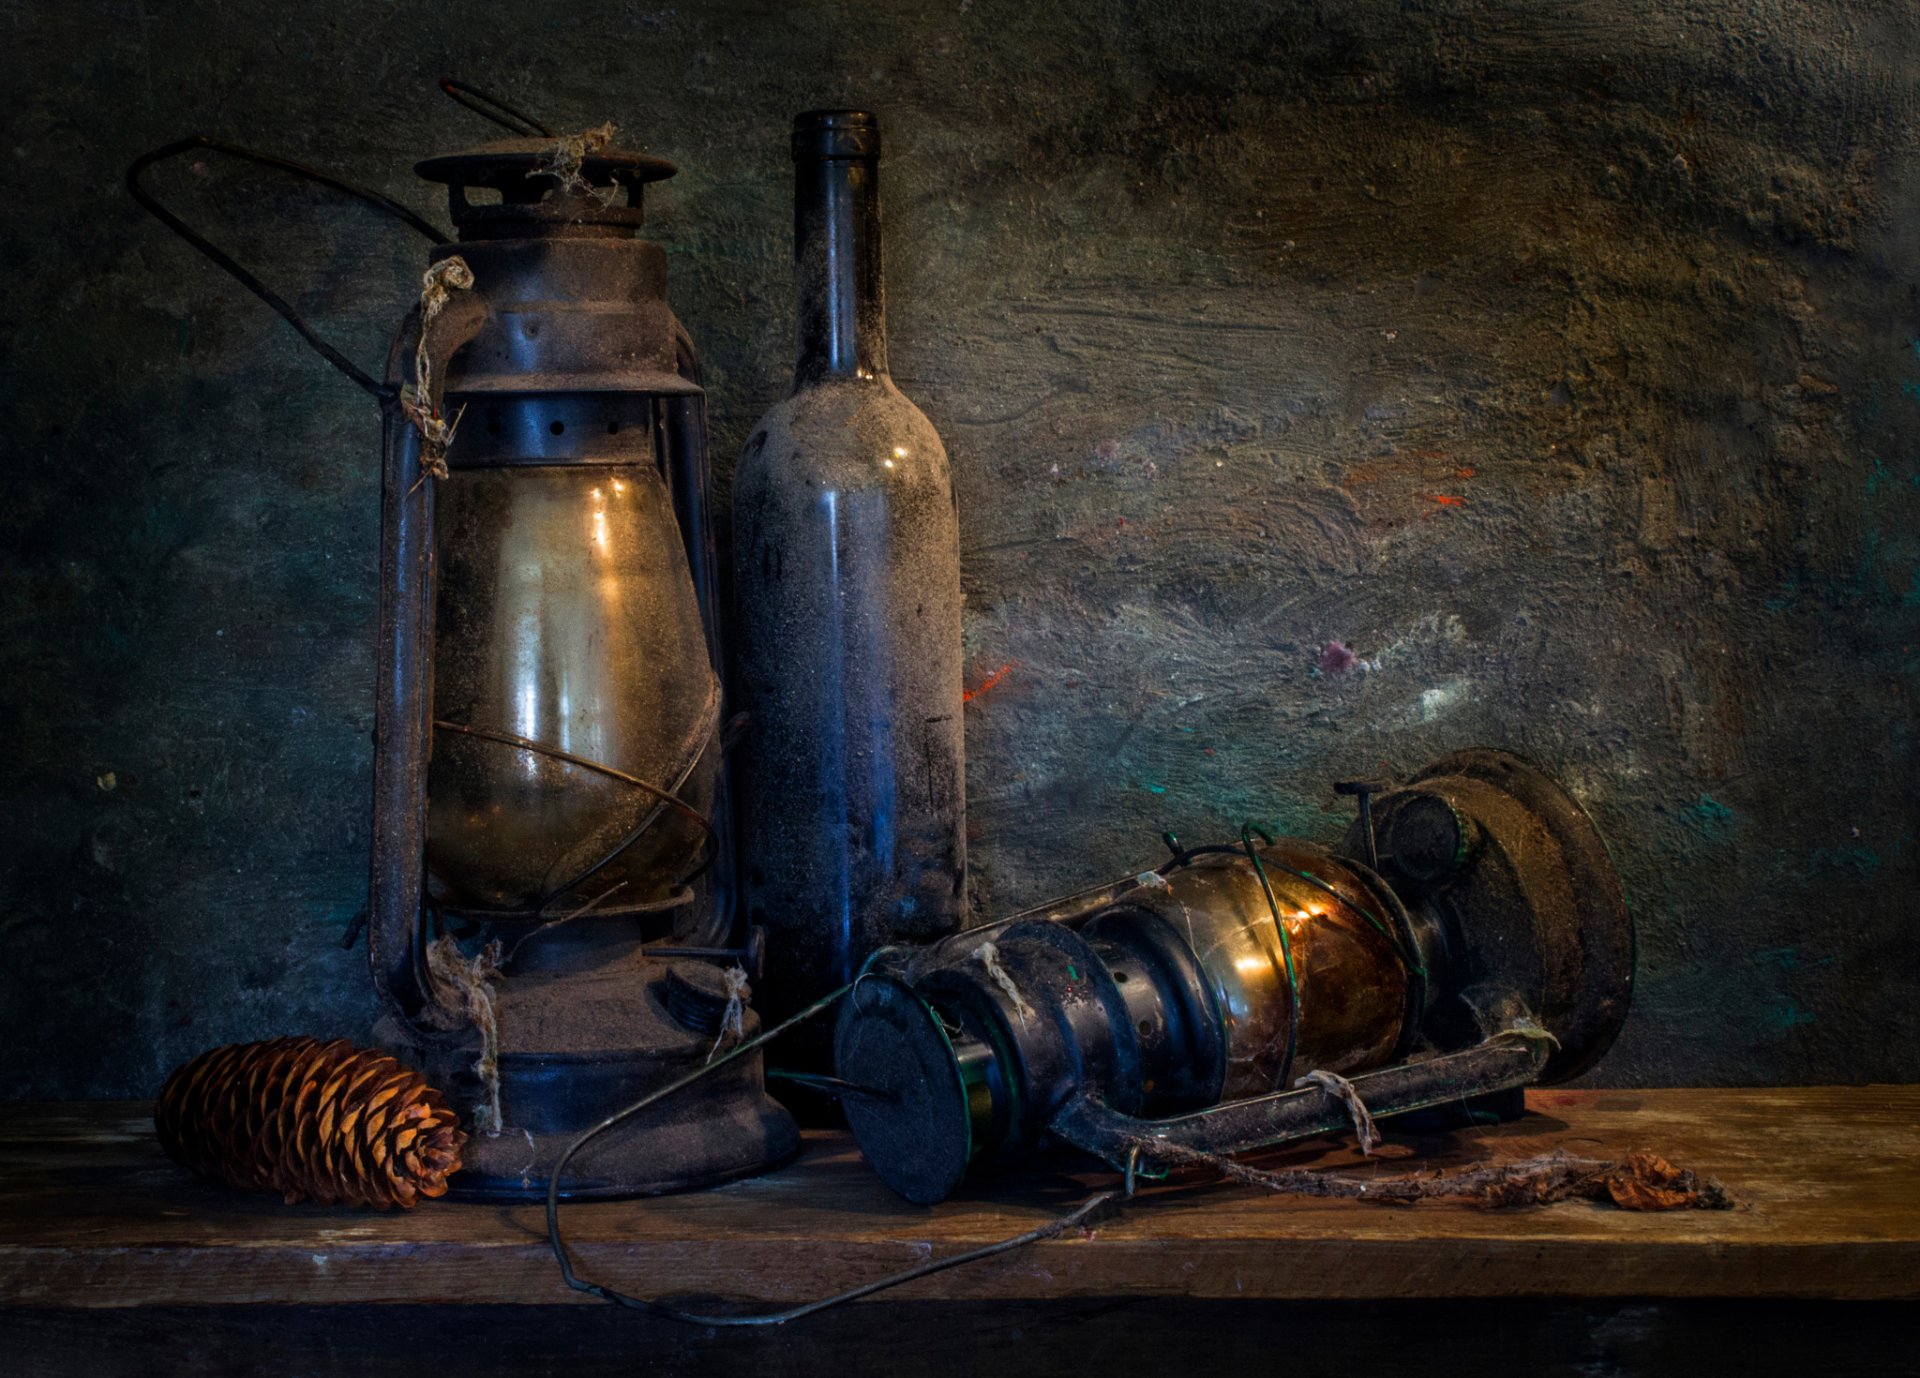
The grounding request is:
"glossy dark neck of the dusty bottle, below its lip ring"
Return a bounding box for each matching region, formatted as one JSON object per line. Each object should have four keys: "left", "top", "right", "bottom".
{"left": 793, "top": 157, "right": 887, "bottom": 388}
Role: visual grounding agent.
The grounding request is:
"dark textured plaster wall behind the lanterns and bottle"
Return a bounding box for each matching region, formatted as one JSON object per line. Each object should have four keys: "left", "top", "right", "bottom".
{"left": 0, "top": 0, "right": 1920, "bottom": 1094}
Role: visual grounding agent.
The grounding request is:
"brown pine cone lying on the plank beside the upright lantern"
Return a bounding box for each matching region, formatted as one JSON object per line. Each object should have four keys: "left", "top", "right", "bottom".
{"left": 154, "top": 1038, "right": 467, "bottom": 1211}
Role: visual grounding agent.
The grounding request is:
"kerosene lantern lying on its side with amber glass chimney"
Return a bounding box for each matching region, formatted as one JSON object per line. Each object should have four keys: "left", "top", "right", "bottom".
{"left": 835, "top": 750, "right": 1634, "bottom": 1203}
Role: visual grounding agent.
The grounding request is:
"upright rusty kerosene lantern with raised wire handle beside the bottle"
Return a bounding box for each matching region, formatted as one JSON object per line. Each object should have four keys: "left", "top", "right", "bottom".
{"left": 129, "top": 96, "right": 799, "bottom": 1200}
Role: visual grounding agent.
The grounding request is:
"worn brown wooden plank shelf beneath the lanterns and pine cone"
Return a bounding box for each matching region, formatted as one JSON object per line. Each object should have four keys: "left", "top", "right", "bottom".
{"left": 0, "top": 1086, "right": 1920, "bottom": 1307}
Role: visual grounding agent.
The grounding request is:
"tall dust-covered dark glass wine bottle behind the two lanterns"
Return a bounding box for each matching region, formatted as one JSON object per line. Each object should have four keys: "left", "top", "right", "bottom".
{"left": 733, "top": 109, "right": 966, "bottom": 1052}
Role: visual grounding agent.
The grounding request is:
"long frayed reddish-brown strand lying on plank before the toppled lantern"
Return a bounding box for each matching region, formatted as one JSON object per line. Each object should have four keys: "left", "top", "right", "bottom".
{"left": 1131, "top": 1134, "right": 1734, "bottom": 1211}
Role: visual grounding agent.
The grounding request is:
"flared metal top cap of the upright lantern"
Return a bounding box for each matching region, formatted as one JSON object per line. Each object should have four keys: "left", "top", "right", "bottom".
{"left": 413, "top": 131, "right": 680, "bottom": 240}
